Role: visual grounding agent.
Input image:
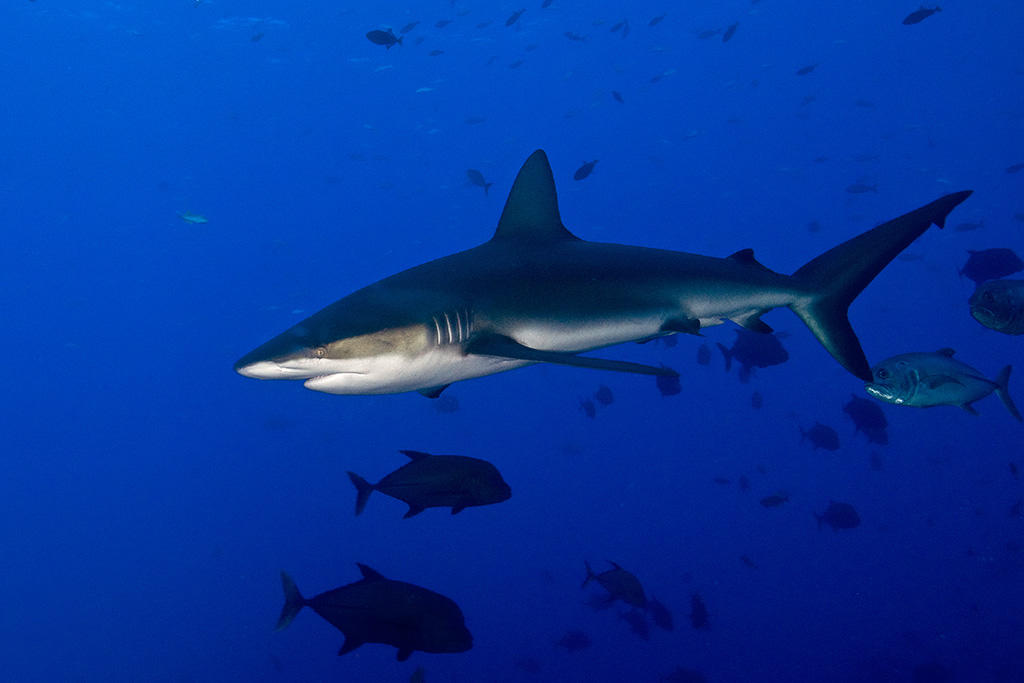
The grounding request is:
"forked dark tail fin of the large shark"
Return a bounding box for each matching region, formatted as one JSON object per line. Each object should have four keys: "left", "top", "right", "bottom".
{"left": 790, "top": 190, "right": 971, "bottom": 382}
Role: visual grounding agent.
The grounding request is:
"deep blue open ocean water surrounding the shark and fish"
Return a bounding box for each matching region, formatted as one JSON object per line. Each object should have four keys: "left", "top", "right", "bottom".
{"left": 0, "top": 0, "right": 1024, "bottom": 682}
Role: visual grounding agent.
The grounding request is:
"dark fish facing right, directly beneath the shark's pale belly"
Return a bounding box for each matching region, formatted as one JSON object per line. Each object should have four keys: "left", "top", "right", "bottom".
{"left": 348, "top": 451, "right": 512, "bottom": 518}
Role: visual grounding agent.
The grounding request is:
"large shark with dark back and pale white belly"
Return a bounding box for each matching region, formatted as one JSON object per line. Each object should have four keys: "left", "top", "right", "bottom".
{"left": 234, "top": 150, "right": 971, "bottom": 397}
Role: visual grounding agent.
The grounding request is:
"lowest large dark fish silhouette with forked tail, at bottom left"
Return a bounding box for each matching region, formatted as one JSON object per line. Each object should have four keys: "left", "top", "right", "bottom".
{"left": 275, "top": 564, "right": 473, "bottom": 661}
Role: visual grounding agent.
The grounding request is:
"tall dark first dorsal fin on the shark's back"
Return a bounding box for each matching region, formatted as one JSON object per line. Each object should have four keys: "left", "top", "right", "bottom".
{"left": 494, "top": 150, "right": 579, "bottom": 243}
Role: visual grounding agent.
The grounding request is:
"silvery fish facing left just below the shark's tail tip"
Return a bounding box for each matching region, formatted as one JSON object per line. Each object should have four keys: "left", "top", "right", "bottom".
{"left": 864, "top": 348, "right": 1024, "bottom": 421}
